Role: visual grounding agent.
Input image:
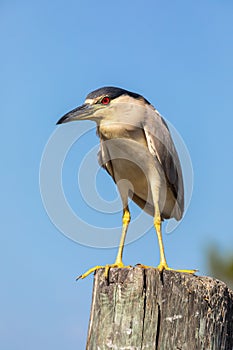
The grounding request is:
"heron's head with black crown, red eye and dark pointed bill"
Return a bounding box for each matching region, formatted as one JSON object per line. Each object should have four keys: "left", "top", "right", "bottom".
{"left": 57, "top": 86, "right": 149, "bottom": 124}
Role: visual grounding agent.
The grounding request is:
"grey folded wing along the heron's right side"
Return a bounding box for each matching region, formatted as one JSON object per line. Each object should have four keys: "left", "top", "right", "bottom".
{"left": 143, "top": 105, "right": 184, "bottom": 220}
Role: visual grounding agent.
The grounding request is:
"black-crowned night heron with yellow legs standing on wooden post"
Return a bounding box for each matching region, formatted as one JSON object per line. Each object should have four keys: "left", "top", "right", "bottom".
{"left": 57, "top": 87, "right": 196, "bottom": 278}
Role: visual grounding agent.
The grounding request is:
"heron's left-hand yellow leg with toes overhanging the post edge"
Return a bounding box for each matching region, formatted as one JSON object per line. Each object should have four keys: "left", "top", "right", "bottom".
{"left": 77, "top": 207, "right": 131, "bottom": 280}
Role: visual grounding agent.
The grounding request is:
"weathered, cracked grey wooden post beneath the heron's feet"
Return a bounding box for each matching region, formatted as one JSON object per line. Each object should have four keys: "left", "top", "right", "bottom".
{"left": 86, "top": 267, "right": 233, "bottom": 350}
